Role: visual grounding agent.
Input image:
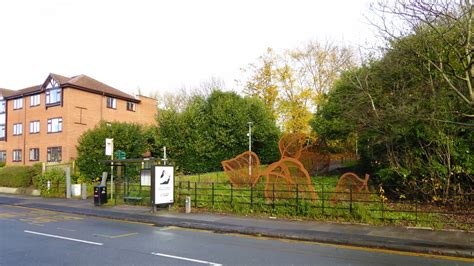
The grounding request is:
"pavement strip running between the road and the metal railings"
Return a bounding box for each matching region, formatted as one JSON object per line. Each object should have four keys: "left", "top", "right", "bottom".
{"left": 0, "top": 194, "right": 474, "bottom": 261}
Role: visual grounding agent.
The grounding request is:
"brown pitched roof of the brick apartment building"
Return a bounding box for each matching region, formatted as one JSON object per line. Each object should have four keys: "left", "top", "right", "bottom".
{"left": 0, "top": 73, "right": 140, "bottom": 102}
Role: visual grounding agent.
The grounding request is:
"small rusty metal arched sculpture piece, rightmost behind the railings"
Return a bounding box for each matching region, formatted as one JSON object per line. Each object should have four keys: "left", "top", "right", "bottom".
{"left": 331, "top": 172, "right": 370, "bottom": 203}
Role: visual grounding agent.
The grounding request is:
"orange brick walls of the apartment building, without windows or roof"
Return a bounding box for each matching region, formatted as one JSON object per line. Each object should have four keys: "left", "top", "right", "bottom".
{"left": 0, "top": 88, "right": 157, "bottom": 165}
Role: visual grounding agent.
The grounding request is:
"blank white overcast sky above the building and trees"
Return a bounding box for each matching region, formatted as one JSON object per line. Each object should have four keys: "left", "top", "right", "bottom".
{"left": 0, "top": 0, "right": 373, "bottom": 97}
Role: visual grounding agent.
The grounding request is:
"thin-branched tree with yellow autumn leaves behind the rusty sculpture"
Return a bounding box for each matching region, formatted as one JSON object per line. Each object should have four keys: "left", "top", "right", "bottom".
{"left": 244, "top": 42, "right": 353, "bottom": 132}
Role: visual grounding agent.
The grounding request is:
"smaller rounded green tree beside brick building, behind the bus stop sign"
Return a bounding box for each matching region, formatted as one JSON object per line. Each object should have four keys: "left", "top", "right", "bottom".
{"left": 76, "top": 122, "right": 154, "bottom": 180}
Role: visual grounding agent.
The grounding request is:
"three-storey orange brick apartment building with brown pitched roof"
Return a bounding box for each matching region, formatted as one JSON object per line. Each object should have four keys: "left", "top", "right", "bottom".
{"left": 0, "top": 74, "right": 157, "bottom": 165}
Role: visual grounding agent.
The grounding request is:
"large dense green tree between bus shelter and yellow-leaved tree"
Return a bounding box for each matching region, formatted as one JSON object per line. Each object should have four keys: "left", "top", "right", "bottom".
{"left": 158, "top": 90, "right": 279, "bottom": 173}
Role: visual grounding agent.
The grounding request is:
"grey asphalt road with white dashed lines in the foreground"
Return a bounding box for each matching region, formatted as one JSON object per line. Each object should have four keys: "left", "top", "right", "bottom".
{"left": 0, "top": 205, "right": 473, "bottom": 266}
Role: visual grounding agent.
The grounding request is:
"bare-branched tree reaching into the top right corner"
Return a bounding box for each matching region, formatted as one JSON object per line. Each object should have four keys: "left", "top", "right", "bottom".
{"left": 374, "top": 0, "right": 474, "bottom": 112}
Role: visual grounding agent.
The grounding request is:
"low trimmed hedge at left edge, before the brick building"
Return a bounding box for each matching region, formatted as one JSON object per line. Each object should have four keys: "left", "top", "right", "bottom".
{"left": 0, "top": 166, "right": 36, "bottom": 187}
